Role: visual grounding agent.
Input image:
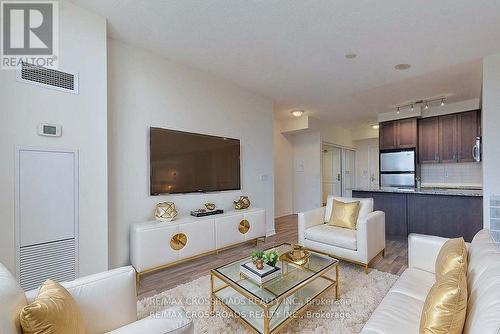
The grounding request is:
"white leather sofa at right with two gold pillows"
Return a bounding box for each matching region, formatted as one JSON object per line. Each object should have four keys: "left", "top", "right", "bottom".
{"left": 361, "top": 230, "right": 500, "bottom": 334}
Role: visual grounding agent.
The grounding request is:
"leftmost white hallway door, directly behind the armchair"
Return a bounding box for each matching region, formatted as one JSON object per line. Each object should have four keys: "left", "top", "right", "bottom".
{"left": 322, "top": 146, "right": 342, "bottom": 203}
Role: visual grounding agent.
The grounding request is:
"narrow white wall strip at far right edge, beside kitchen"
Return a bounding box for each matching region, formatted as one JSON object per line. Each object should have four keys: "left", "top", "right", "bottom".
{"left": 482, "top": 54, "right": 500, "bottom": 228}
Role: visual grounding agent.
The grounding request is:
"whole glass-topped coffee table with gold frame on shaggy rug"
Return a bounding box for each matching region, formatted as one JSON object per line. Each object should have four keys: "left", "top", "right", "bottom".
{"left": 210, "top": 243, "right": 339, "bottom": 334}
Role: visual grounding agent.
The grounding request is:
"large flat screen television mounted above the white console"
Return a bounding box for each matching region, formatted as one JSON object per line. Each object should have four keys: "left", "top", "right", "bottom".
{"left": 149, "top": 127, "right": 241, "bottom": 195}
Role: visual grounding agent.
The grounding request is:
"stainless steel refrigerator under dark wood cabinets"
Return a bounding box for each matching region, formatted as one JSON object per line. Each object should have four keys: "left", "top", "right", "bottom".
{"left": 380, "top": 149, "right": 416, "bottom": 188}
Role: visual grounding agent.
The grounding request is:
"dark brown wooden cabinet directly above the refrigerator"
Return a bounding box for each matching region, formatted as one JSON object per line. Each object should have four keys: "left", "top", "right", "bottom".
{"left": 379, "top": 118, "right": 417, "bottom": 150}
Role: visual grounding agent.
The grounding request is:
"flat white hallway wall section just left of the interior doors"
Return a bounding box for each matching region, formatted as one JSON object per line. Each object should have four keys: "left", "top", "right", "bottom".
{"left": 292, "top": 132, "right": 321, "bottom": 213}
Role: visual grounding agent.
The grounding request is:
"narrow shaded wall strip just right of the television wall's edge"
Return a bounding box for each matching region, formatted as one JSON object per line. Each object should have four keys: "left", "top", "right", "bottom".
{"left": 274, "top": 120, "right": 293, "bottom": 217}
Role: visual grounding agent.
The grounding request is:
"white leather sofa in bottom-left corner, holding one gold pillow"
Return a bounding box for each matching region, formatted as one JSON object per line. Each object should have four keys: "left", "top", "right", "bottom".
{"left": 0, "top": 264, "right": 193, "bottom": 334}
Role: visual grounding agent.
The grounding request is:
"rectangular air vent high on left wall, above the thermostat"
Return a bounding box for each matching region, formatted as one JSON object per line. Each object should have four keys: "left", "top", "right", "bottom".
{"left": 17, "top": 62, "right": 78, "bottom": 94}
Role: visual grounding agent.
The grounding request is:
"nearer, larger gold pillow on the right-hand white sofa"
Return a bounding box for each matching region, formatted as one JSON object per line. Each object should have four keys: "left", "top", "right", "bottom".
{"left": 420, "top": 269, "right": 467, "bottom": 334}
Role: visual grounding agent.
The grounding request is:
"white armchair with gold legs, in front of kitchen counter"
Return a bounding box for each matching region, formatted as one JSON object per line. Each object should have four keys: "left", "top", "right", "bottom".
{"left": 298, "top": 196, "right": 385, "bottom": 272}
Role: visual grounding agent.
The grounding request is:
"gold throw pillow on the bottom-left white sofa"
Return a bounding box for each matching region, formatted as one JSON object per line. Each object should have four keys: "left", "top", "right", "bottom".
{"left": 19, "top": 279, "right": 85, "bottom": 334}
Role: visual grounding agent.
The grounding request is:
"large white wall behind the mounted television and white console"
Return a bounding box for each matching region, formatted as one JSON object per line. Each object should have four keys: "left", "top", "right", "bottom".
{"left": 108, "top": 40, "right": 274, "bottom": 267}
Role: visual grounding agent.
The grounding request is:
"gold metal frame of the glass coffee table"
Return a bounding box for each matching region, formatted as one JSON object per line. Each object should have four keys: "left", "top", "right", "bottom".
{"left": 210, "top": 243, "right": 339, "bottom": 334}
